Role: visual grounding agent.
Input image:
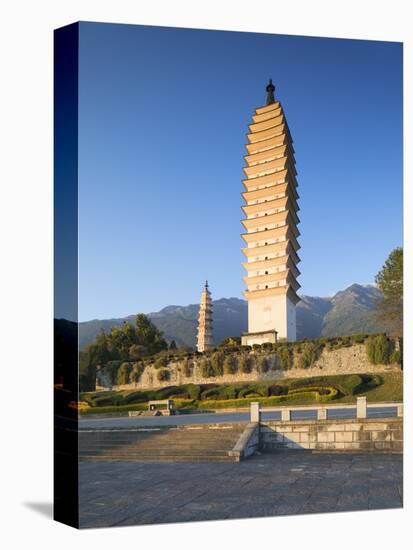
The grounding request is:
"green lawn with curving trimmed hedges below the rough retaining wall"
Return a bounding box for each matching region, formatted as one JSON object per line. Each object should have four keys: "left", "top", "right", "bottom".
{"left": 80, "top": 372, "right": 403, "bottom": 414}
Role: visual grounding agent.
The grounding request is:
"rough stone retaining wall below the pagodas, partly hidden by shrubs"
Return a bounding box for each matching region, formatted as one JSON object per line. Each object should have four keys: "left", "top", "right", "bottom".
{"left": 113, "top": 344, "right": 400, "bottom": 390}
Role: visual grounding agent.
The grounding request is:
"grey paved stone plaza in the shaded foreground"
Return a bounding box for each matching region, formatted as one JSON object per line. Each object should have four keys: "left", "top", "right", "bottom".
{"left": 80, "top": 451, "right": 403, "bottom": 528}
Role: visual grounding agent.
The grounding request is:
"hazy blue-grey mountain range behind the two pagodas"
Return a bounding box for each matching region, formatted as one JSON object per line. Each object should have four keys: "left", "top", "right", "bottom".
{"left": 79, "top": 284, "right": 383, "bottom": 349}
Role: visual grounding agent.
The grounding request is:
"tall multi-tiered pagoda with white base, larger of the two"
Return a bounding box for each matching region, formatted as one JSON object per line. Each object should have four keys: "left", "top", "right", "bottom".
{"left": 242, "top": 80, "right": 300, "bottom": 345}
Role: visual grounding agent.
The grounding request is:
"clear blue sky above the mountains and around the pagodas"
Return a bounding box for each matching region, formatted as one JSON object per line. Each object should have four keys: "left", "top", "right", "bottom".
{"left": 75, "top": 23, "right": 402, "bottom": 320}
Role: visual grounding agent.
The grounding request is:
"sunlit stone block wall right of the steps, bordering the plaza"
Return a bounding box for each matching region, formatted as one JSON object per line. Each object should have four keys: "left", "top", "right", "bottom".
{"left": 260, "top": 418, "right": 403, "bottom": 453}
